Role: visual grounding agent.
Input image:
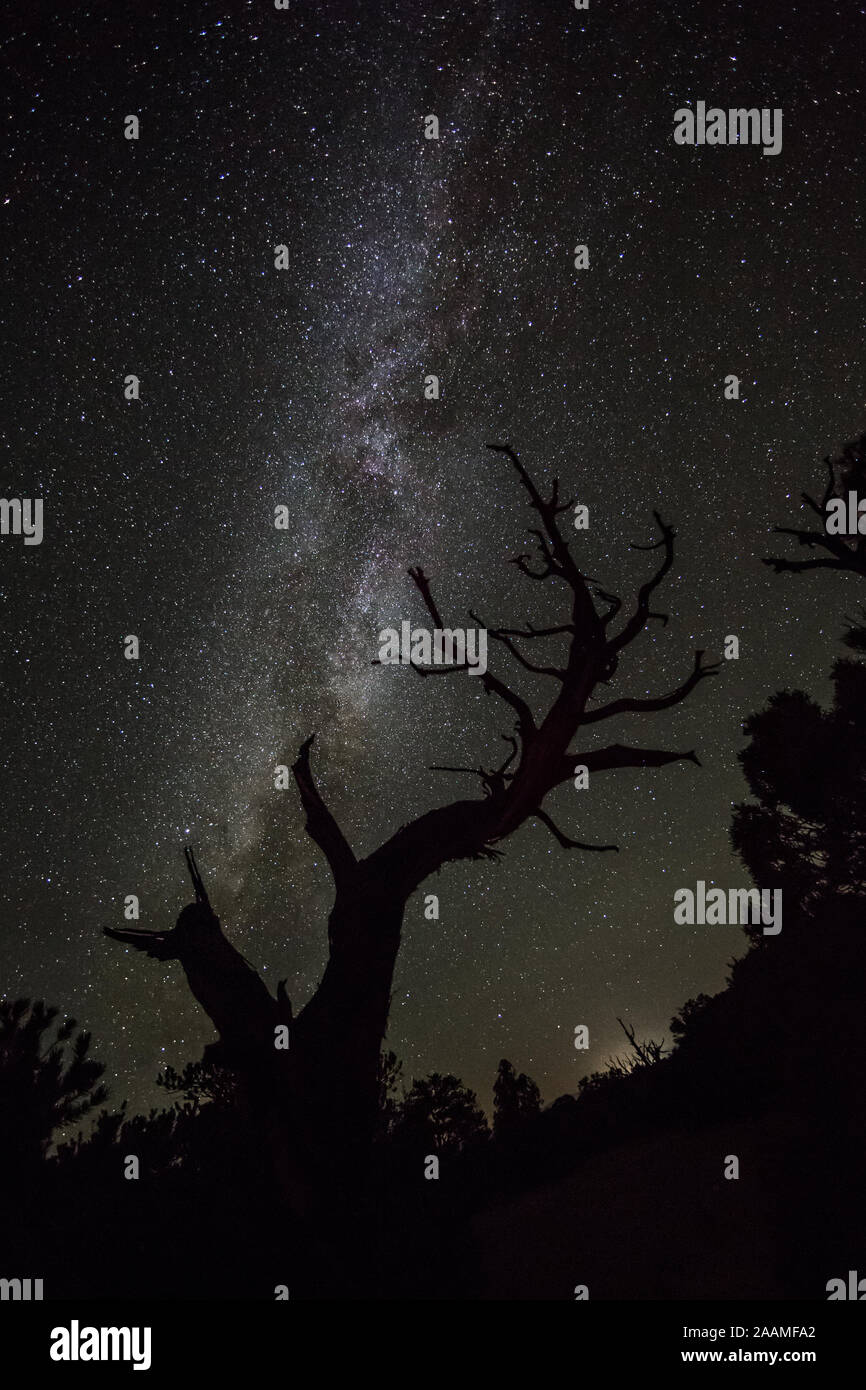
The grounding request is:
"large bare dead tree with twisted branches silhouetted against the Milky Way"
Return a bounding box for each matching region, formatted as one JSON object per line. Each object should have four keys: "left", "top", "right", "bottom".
{"left": 104, "top": 445, "right": 719, "bottom": 1206}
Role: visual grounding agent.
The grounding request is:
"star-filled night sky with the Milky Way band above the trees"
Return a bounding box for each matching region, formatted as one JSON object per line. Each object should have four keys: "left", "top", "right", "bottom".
{"left": 0, "top": 0, "right": 866, "bottom": 1108}
